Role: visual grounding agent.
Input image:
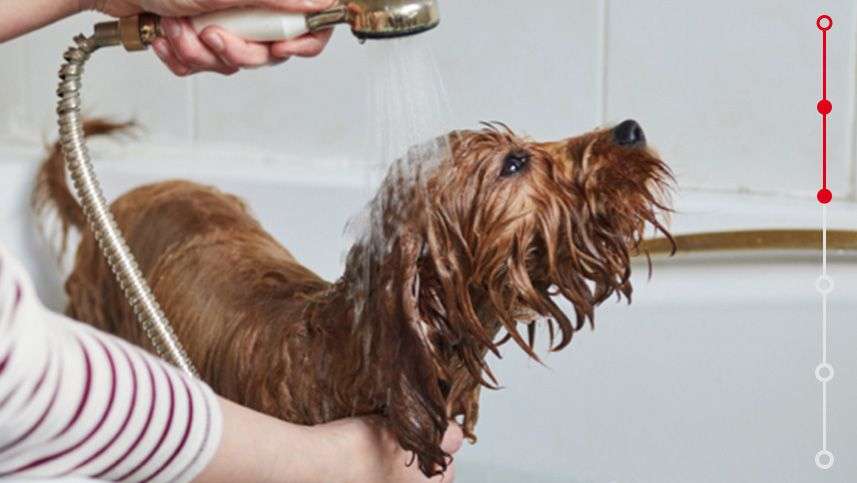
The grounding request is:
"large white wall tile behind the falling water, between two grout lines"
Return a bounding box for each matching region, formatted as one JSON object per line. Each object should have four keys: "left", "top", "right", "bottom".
{"left": 191, "top": 0, "right": 598, "bottom": 163}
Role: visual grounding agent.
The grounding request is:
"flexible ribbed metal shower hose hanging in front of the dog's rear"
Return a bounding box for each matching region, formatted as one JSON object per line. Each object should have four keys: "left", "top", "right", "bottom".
{"left": 57, "top": 35, "right": 199, "bottom": 377}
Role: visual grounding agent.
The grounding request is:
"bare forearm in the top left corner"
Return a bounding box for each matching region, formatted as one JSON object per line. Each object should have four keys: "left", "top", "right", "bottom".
{"left": 0, "top": 0, "right": 88, "bottom": 42}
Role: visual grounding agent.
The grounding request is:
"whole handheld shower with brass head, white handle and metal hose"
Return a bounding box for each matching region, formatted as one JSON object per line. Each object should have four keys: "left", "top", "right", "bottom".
{"left": 57, "top": 0, "right": 440, "bottom": 377}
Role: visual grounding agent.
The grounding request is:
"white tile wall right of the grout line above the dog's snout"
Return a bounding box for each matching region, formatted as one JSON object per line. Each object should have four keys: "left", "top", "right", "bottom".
{"left": 606, "top": 0, "right": 857, "bottom": 199}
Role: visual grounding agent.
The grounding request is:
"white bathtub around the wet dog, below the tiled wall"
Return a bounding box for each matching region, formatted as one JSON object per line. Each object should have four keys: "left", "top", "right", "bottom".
{"left": 0, "top": 148, "right": 857, "bottom": 483}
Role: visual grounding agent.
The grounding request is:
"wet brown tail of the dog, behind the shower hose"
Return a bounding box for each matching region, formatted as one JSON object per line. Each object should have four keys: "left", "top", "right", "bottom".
{"left": 32, "top": 120, "right": 134, "bottom": 259}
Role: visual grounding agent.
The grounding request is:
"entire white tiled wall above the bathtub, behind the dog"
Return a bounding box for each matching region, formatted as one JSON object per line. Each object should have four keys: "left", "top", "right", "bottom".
{"left": 0, "top": 0, "right": 857, "bottom": 199}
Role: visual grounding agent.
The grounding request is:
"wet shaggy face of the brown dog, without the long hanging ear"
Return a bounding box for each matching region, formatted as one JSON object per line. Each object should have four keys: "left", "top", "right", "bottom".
{"left": 408, "top": 120, "right": 672, "bottom": 362}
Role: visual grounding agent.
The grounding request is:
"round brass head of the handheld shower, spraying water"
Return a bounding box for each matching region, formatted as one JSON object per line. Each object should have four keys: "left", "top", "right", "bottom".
{"left": 343, "top": 0, "right": 440, "bottom": 39}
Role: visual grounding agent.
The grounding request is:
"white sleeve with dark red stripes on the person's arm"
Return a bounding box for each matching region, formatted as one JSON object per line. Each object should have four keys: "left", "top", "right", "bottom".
{"left": 0, "top": 246, "right": 222, "bottom": 482}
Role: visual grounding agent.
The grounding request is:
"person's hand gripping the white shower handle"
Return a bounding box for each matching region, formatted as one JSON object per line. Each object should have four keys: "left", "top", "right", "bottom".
{"left": 80, "top": 0, "right": 334, "bottom": 76}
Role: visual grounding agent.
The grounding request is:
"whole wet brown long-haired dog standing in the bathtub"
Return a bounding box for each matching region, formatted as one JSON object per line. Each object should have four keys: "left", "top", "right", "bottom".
{"left": 35, "top": 121, "right": 672, "bottom": 475}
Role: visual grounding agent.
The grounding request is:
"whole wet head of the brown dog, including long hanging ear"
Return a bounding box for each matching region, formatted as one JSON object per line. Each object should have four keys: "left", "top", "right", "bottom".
{"left": 344, "top": 120, "right": 672, "bottom": 476}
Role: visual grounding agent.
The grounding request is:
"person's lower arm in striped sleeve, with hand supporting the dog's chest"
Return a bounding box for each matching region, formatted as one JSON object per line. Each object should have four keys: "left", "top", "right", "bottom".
{"left": 0, "top": 243, "right": 462, "bottom": 483}
